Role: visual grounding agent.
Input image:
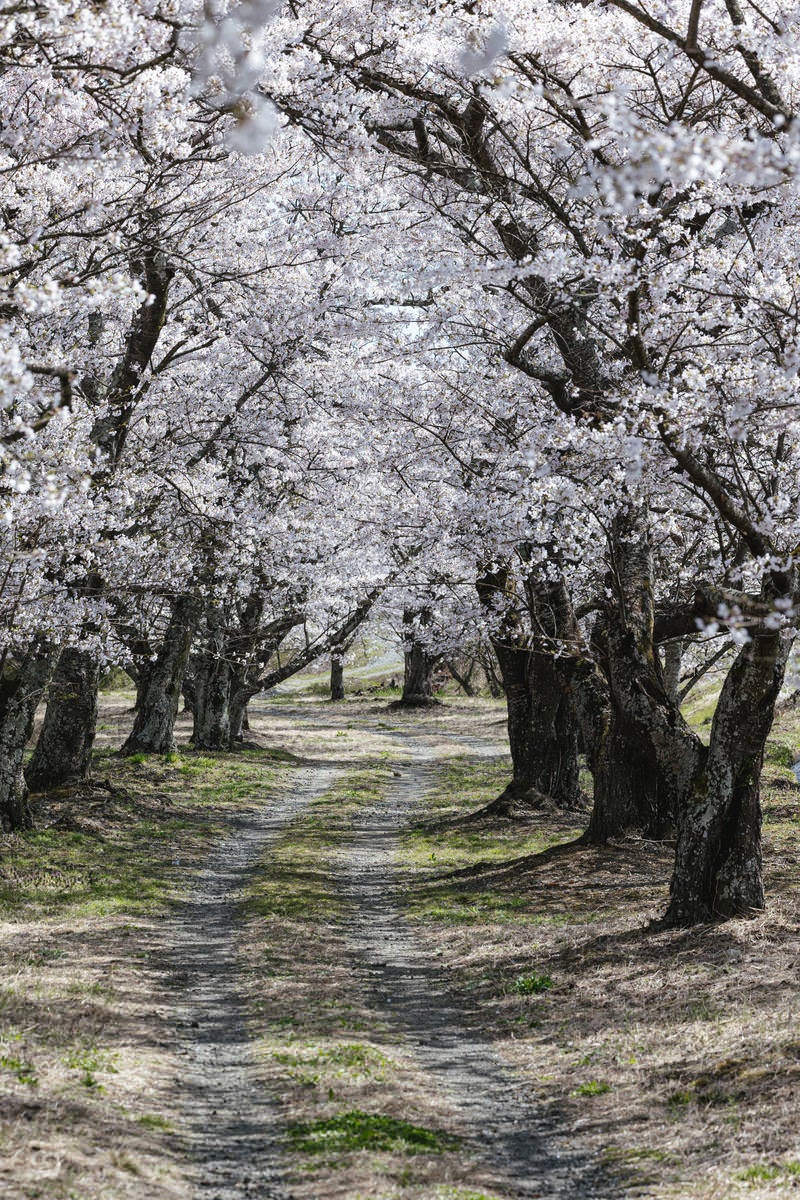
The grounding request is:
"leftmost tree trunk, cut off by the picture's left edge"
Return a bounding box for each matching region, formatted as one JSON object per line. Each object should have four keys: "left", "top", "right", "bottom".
{"left": 0, "top": 640, "right": 55, "bottom": 830}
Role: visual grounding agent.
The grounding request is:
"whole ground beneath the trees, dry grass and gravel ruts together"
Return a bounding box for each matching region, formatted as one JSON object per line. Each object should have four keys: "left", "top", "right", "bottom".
{"left": 0, "top": 696, "right": 800, "bottom": 1200}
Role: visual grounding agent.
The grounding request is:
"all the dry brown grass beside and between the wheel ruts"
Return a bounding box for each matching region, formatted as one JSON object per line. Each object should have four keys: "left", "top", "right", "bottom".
{"left": 0, "top": 697, "right": 800, "bottom": 1200}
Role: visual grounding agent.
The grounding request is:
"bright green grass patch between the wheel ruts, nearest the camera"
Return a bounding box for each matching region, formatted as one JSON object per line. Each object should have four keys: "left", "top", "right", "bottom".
{"left": 288, "top": 1109, "right": 461, "bottom": 1154}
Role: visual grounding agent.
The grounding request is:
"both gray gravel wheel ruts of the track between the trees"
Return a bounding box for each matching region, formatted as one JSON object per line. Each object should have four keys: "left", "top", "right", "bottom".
{"left": 165, "top": 707, "right": 609, "bottom": 1200}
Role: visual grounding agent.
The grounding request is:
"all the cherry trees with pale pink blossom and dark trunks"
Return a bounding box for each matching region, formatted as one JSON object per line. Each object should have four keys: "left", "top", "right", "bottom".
{"left": 0, "top": 0, "right": 800, "bottom": 924}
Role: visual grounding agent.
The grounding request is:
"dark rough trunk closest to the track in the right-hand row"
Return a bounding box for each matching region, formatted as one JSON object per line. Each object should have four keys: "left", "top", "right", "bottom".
{"left": 477, "top": 571, "right": 581, "bottom": 811}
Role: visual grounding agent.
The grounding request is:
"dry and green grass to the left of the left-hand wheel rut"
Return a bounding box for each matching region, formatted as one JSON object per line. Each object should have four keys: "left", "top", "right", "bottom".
{"left": 0, "top": 697, "right": 293, "bottom": 1200}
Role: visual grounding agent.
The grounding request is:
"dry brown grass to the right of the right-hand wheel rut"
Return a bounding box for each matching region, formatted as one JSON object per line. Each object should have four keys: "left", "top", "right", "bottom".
{"left": 402, "top": 739, "right": 800, "bottom": 1200}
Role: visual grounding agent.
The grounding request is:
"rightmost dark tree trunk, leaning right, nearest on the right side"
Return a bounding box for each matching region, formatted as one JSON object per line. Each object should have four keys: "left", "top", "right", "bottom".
{"left": 666, "top": 629, "right": 792, "bottom": 925}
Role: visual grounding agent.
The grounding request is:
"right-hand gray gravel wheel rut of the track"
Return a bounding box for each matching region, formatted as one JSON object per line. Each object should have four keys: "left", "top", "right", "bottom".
{"left": 342, "top": 739, "right": 610, "bottom": 1200}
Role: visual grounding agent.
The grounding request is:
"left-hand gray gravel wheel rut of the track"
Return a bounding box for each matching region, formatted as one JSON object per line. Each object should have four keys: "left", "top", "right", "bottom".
{"left": 167, "top": 767, "right": 335, "bottom": 1200}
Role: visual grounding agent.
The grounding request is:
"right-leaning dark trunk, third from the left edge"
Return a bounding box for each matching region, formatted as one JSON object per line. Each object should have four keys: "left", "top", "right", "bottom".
{"left": 121, "top": 596, "right": 197, "bottom": 755}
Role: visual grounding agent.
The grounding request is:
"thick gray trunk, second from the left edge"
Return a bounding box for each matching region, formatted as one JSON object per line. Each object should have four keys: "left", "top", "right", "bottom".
{"left": 25, "top": 649, "right": 100, "bottom": 792}
